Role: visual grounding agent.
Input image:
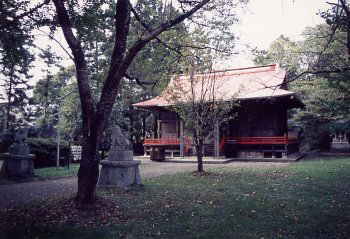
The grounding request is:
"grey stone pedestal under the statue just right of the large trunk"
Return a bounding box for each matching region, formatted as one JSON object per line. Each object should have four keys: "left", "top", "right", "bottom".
{"left": 98, "top": 160, "right": 141, "bottom": 188}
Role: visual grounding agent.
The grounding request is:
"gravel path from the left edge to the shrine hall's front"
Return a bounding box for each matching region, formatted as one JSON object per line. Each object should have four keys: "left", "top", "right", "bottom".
{"left": 0, "top": 160, "right": 288, "bottom": 209}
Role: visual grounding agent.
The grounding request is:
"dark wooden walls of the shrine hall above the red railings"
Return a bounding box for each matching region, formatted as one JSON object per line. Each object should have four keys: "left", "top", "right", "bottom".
{"left": 152, "top": 99, "right": 288, "bottom": 137}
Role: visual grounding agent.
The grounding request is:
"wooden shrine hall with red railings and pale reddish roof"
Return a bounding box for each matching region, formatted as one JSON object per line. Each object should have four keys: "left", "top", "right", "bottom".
{"left": 134, "top": 64, "right": 303, "bottom": 160}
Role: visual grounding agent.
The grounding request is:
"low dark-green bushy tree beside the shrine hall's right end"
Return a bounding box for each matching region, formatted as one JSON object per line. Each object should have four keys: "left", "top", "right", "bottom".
{"left": 292, "top": 77, "right": 348, "bottom": 151}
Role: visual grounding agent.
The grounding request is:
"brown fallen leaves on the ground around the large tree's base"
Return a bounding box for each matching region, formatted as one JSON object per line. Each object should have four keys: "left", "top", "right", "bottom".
{"left": 0, "top": 198, "right": 128, "bottom": 230}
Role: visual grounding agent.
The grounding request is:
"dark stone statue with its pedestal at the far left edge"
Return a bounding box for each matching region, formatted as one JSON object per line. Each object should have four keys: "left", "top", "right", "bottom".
{"left": 0, "top": 129, "right": 34, "bottom": 179}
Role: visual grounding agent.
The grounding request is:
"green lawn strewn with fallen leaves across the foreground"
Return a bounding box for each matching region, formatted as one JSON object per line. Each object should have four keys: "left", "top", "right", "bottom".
{"left": 0, "top": 158, "right": 350, "bottom": 239}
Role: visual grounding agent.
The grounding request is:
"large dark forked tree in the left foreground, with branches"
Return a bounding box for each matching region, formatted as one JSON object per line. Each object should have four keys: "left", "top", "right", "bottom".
{"left": 49, "top": 0, "right": 245, "bottom": 204}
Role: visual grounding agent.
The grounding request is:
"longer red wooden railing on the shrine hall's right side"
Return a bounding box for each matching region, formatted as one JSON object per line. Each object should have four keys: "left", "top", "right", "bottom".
{"left": 219, "top": 136, "right": 298, "bottom": 150}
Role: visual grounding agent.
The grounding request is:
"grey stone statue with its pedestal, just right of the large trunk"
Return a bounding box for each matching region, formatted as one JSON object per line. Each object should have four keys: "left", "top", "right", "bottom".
{"left": 98, "top": 126, "right": 141, "bottom": 189}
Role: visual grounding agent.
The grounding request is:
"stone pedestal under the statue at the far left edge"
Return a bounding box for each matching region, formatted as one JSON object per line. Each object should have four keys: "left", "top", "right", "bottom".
{"left": 0, "top": 153, "right": 34, "bottom": 178}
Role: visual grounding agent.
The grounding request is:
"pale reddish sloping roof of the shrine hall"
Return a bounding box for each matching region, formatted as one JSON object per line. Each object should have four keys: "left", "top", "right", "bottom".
{"left": 134, "top": 64, "right": 295, "bottom": 108}
